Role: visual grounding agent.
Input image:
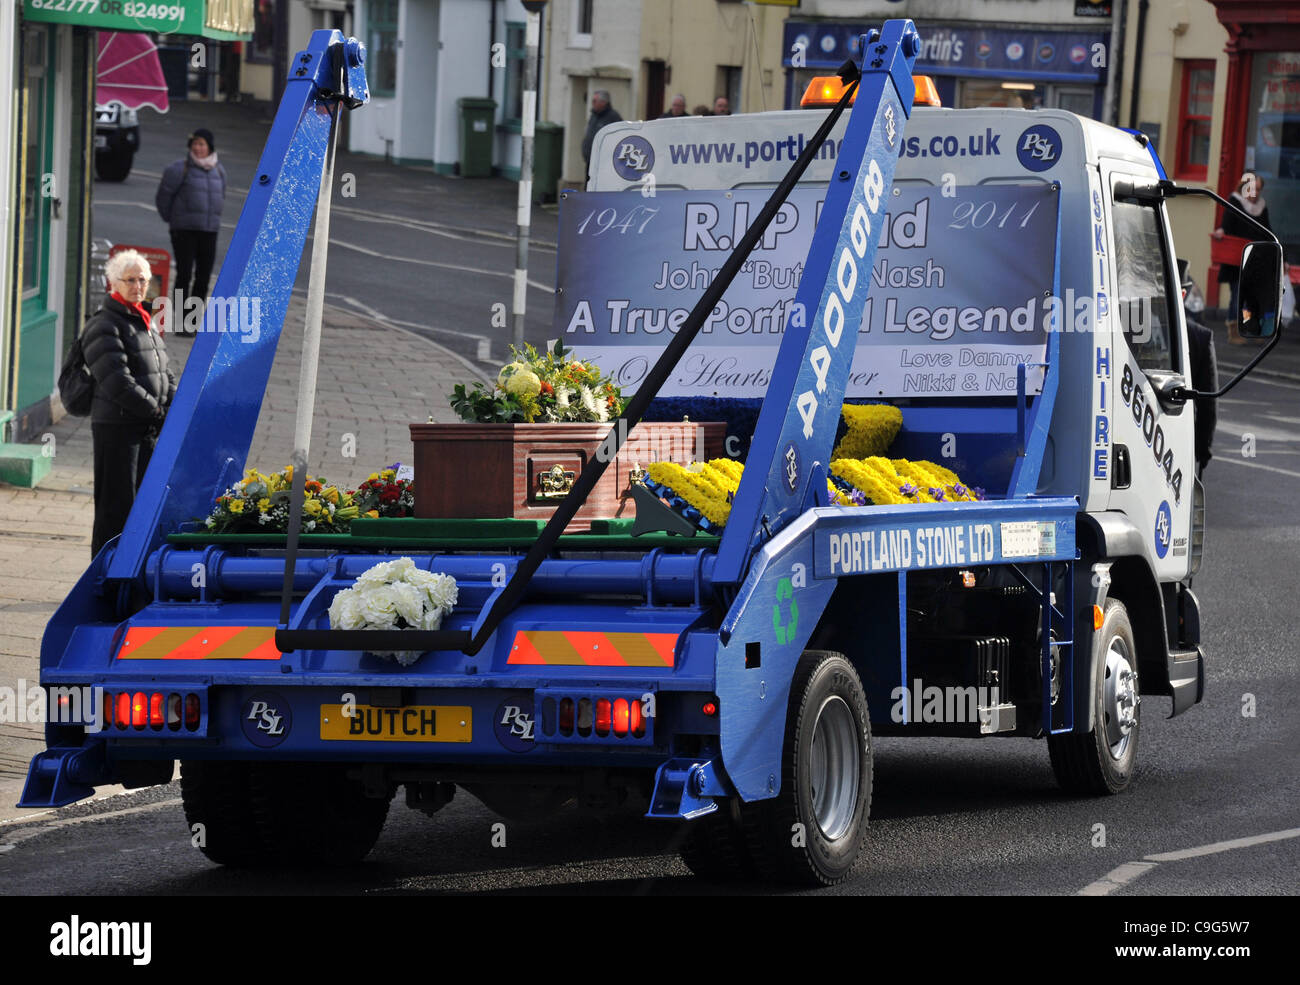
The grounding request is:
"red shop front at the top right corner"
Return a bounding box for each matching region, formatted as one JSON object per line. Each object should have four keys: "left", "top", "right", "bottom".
{"left": 1213, "top": 0, "right": 1300, "bottom": 274}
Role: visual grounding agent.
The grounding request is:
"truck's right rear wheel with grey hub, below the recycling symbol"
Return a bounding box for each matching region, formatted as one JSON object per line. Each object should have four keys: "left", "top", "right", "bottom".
{"left": 740, "top": 650, "right": 871, "bottom": 886}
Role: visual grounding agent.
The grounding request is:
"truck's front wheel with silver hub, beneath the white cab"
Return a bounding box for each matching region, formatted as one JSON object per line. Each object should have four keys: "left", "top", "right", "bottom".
{"left": 1048, "top": 599, "right": 1141, "bottom": 794}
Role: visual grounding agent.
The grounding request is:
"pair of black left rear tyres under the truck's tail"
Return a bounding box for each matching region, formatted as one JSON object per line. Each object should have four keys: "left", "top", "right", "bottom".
{"left": 181, "top": 761, "right": 393, "bottom": 865}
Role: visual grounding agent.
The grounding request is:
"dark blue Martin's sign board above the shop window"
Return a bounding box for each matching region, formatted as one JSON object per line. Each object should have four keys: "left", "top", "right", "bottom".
{"left": 783, "top": 21, "right": 1110, "bottom": 84}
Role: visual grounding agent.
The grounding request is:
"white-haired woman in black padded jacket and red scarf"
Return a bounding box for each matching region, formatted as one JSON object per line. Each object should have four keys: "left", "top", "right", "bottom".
{"left": 82, "top": 249, "right": 176, "bottom": 556}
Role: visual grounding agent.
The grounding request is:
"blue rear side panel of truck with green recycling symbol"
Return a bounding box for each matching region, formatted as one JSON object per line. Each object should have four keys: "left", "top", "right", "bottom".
{"left": 715, "top": 512, "right": 836, "bottom": 800}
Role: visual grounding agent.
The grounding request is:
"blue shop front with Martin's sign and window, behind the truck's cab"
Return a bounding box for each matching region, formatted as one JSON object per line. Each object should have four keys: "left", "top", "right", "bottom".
{"left": 784, "top": 21, "right": 1110, "bottom": 117}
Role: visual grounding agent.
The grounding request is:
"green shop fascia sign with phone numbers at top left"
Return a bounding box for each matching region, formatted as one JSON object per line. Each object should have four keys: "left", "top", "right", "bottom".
{"left": 22, "top": 0, "right": 252, "bottom": 40}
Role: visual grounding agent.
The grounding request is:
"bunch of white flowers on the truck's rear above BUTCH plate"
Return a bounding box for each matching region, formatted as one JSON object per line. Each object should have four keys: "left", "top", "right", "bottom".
{"left": 329, "top": 557, "right": 456, "bottom": 667}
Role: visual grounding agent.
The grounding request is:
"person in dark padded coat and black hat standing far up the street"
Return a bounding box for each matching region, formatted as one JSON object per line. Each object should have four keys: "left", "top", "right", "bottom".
{"left": 153, "top": 127, "right": 226, "bottom": 314}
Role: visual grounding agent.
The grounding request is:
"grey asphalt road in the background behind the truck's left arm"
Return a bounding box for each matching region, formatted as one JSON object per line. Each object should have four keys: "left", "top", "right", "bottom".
{"left": 92, "top": 103, "right": 558, "bottom": 373}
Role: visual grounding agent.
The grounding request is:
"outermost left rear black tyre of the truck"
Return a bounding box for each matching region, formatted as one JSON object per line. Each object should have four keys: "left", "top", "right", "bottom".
{"left": 181, "top": 760, "right": 265, "bottom": 865}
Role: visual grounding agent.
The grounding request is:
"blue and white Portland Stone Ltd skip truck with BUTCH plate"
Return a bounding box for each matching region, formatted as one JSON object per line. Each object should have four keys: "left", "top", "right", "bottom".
{"left": 21, "top": 19, "right": 1281, "bottom": 885}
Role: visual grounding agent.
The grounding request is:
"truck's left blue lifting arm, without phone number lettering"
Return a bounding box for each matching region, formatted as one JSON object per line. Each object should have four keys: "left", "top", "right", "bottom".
{"left": 99, "top": 31, "right": 369, "bottom": 581}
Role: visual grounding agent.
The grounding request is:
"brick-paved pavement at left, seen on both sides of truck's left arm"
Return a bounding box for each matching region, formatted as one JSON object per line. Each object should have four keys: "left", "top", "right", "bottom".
{"left": 0, "top": 296, "right": 482, "bottom": 820}
